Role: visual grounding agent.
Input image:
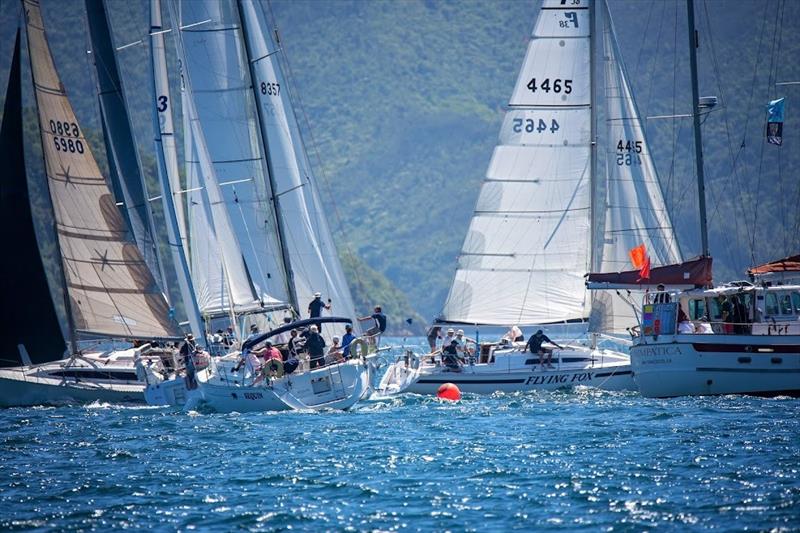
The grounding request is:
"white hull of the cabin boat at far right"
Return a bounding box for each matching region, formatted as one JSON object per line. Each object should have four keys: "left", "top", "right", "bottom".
{"left": 631, "top": 335, "right": 800, "bottom": 398}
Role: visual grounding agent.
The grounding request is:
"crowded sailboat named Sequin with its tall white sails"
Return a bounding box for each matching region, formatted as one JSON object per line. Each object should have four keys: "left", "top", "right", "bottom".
{"left": 139, "top": 1, "right": 370, "bottom": 411}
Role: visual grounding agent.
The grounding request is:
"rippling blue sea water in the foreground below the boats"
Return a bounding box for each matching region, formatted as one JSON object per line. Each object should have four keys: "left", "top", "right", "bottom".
{"left": 0, "top": 338, "right": 800, "bottom": 531}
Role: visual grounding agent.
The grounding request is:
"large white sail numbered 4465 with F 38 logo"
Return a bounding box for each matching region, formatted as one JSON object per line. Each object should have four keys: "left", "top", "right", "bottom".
{"left": 441, "top": 0, "right": 593, "bottom": 325}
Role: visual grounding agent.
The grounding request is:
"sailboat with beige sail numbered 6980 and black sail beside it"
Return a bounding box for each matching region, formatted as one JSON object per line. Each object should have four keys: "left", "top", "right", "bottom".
{"left": 0, "top": 0, "right": 181, "bottom": 405}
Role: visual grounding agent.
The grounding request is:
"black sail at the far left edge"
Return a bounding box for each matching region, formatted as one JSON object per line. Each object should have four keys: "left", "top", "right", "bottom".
{"left": 0, "top": 30, "right": 66, "bottom": 366}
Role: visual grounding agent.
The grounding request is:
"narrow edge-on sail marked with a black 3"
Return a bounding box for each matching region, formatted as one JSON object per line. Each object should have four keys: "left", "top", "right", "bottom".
{"left": 150, "top": 0, "right": 205, "bottom": 339}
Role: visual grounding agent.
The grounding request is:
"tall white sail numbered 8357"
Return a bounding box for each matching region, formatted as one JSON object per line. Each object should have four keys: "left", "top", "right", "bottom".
{"left": 239, "top": 0, "right": 355, "bottom": 324}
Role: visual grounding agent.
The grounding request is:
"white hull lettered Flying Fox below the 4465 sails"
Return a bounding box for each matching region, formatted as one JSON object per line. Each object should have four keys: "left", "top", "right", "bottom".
{"left": 379, "top": 347, "right": 636, "bottom": 394}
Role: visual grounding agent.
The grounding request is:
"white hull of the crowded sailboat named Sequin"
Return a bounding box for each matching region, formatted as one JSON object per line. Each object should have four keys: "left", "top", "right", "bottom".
{"left": 145, "top": 359, "right": 370, "bottom": 413}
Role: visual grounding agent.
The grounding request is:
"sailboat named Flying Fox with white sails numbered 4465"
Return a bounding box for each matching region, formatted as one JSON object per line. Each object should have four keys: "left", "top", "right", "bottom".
{"left": 381, "top": 0, "right": 680, "bottom": 393}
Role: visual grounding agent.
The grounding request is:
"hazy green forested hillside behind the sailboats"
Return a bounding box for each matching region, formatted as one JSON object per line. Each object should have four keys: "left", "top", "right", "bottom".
{"left": 0, "top": 0, "right": 800, "bottom": 327}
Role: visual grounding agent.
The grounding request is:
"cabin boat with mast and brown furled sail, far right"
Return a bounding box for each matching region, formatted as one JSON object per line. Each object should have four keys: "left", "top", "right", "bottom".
{"left": 589, "top": 0, "right": 800, "bottom": 398}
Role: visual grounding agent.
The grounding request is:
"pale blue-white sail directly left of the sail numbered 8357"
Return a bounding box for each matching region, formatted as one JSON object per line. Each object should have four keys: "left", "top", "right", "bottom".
{"left": 173, "top": 0, "right": 287, "bottom": 314}
